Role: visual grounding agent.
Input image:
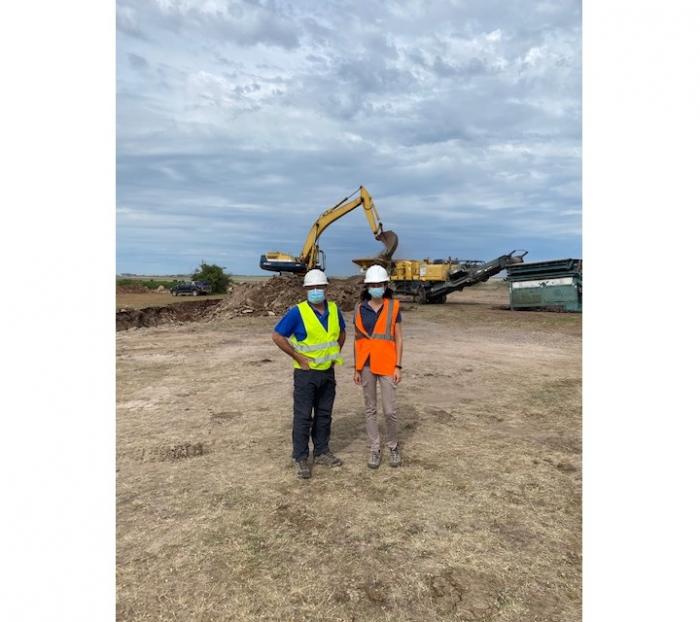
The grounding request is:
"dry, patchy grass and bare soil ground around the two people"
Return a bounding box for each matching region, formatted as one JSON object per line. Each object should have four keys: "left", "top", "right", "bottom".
{"left": 117, "top": 281, "right": 581, "bottom": 622}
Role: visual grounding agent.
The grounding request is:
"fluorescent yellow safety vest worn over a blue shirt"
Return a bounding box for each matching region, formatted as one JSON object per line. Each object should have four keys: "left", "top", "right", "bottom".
{"left": 289, "top": 300, "right": 343, "bottom": 369}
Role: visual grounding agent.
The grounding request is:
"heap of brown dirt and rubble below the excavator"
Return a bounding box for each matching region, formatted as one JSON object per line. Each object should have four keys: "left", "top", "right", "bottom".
{"left": 207, "top": 275, "right": 362, "bottom": 319}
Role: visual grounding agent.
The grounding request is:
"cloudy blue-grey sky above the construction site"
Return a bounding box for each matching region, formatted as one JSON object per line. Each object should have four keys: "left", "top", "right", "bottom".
{"left": 117, "top": 0, "right": 581, "bottom": 275}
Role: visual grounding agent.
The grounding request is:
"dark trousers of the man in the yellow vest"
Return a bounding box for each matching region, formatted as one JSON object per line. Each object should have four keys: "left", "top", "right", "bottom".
{"left": 292, "top": 367, "right": 335, "bottom": 460}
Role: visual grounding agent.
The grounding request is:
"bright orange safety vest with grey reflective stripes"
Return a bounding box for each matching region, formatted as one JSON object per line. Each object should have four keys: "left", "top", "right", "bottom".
{"left": 355, "top": 298, "right": 399, "bottom": 376}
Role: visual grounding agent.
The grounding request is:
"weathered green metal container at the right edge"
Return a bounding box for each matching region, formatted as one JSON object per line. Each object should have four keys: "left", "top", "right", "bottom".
{"left": 506, "top": 259, "right": 583, "bottom": 313}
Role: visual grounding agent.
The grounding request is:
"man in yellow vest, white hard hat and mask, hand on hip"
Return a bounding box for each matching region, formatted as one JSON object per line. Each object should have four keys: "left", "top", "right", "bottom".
{"left": 272, "top": 270, "right": 345, "bottom": 479}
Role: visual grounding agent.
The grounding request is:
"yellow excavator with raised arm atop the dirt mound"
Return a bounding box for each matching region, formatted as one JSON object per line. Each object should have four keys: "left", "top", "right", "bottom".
{"left": 260, "top": 186, "right": 399, "bottom": 274}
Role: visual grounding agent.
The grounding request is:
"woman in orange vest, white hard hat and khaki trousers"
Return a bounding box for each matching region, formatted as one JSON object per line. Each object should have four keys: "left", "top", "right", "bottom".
{"left": 353, "top": 266, "right": 403, "bottom": 469}
